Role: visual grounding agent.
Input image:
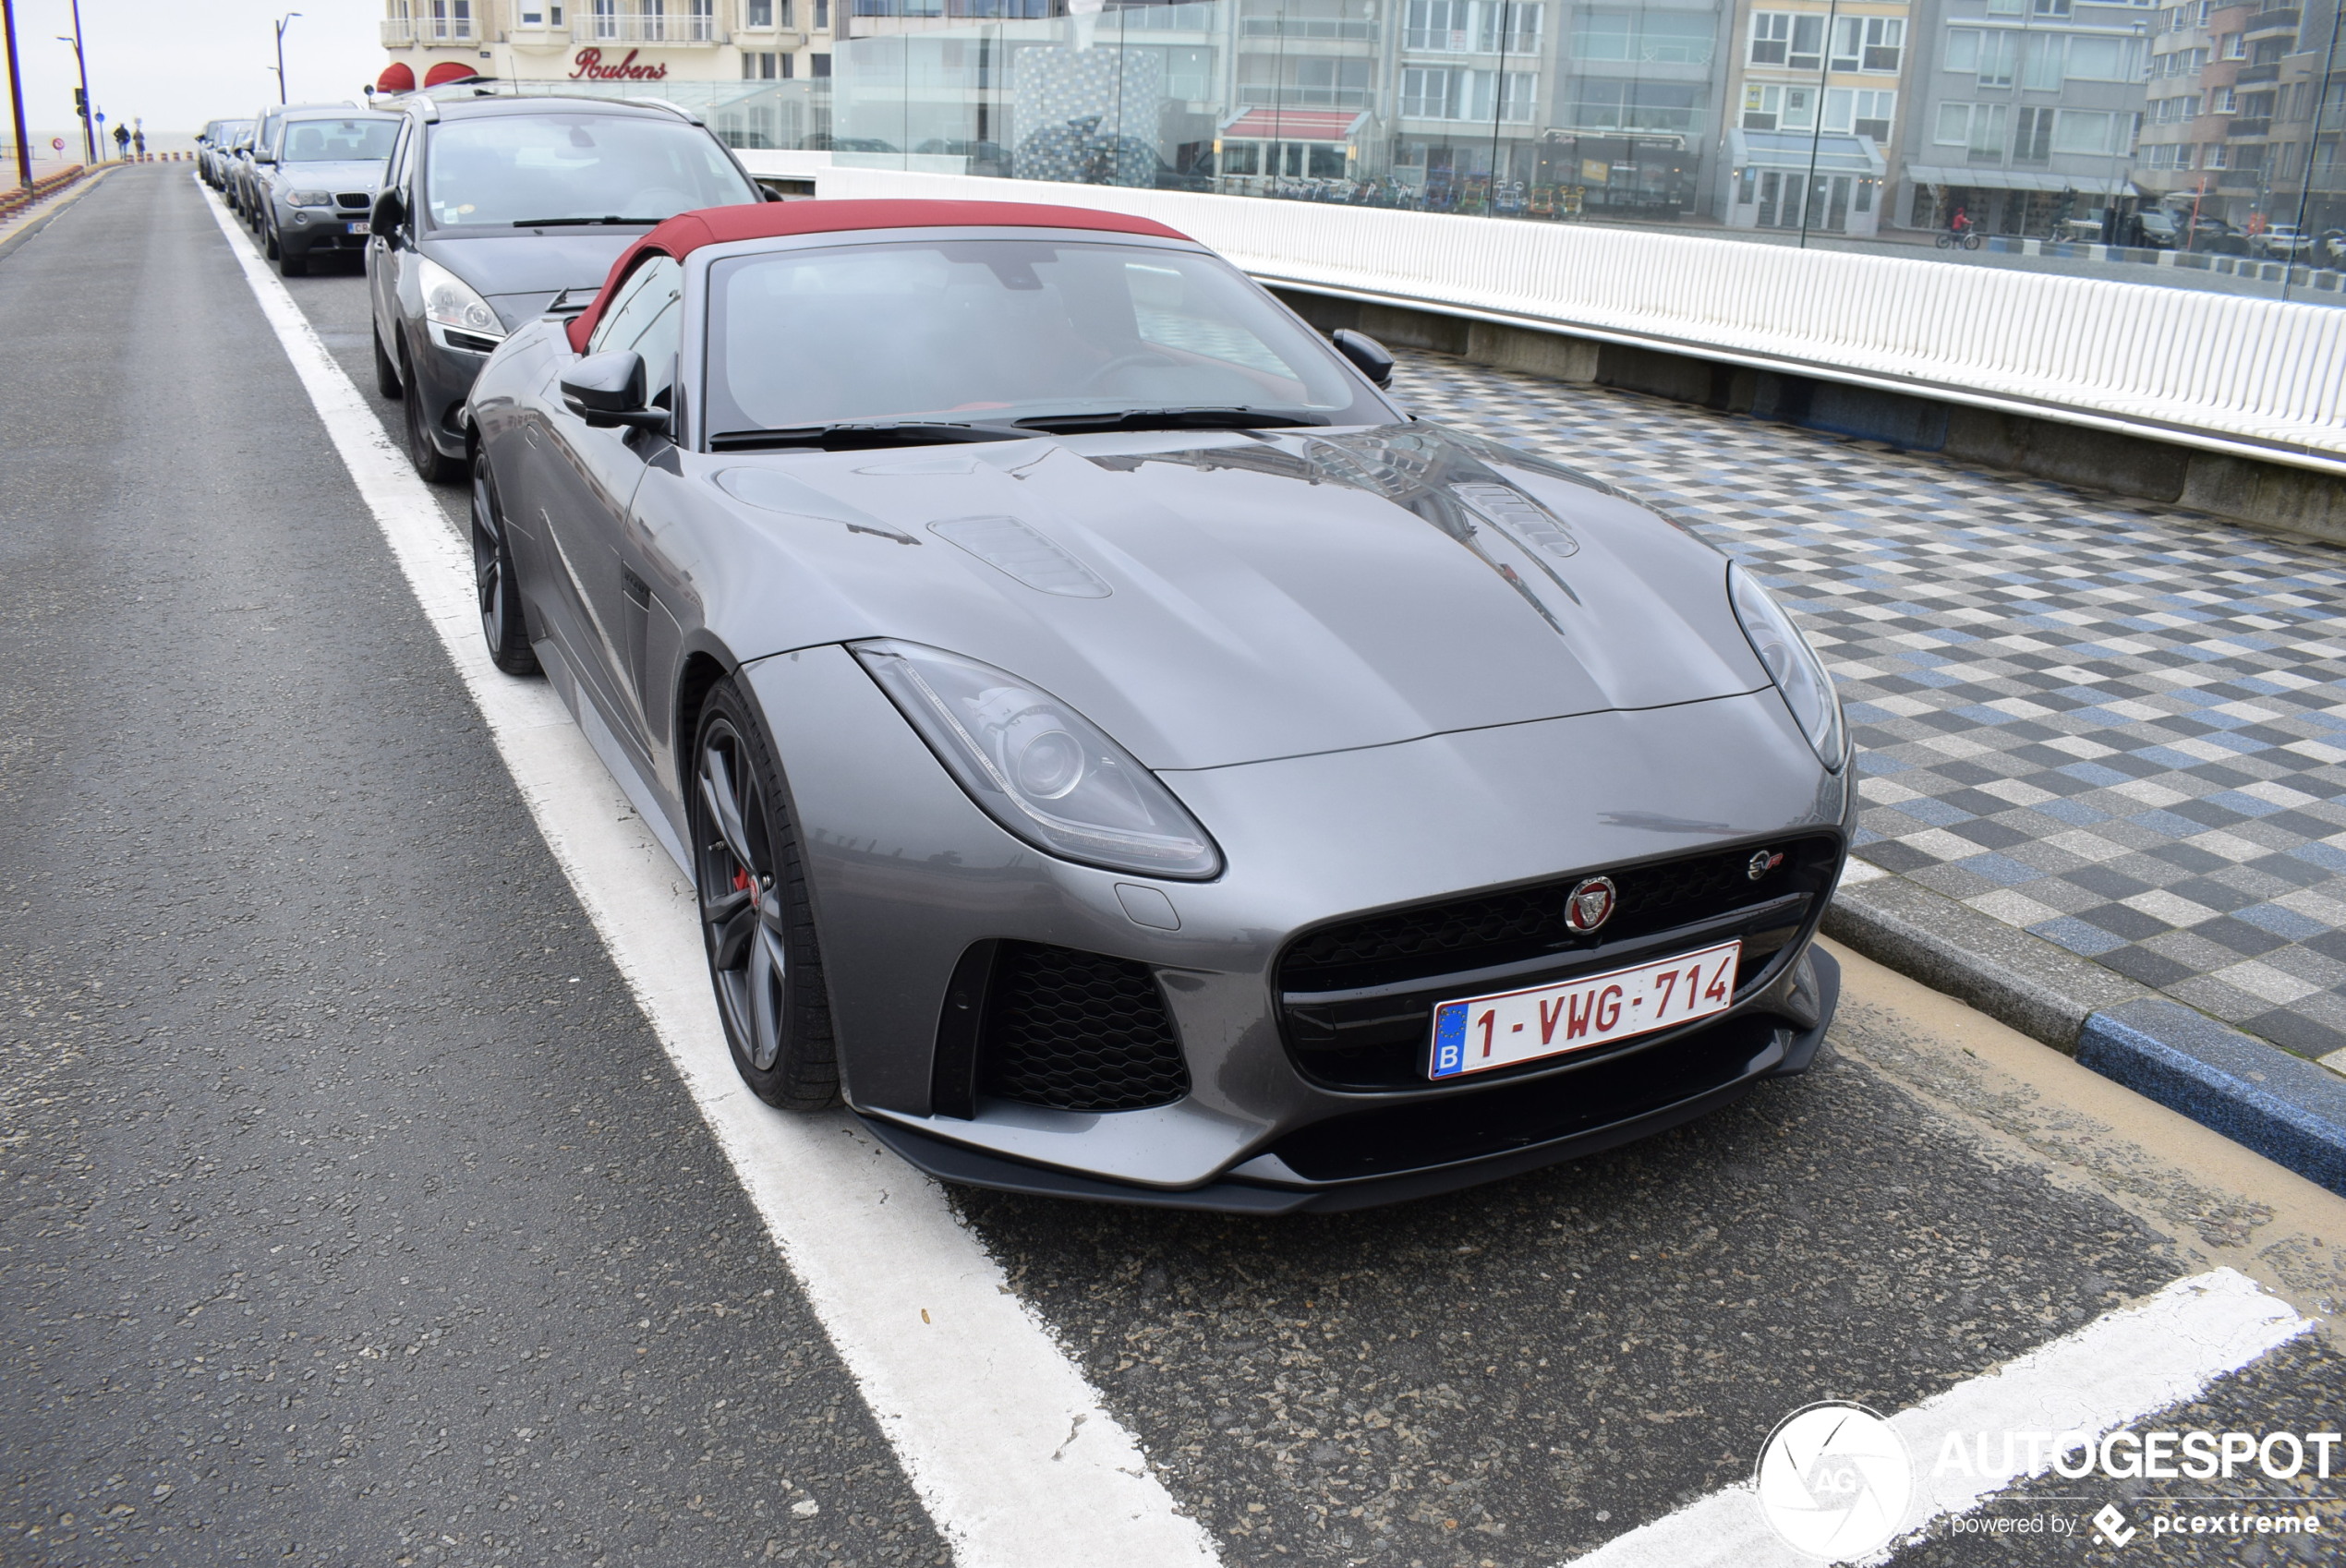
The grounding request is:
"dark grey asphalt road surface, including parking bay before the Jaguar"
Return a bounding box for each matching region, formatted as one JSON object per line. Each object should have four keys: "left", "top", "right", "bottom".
{"left": 0, "top": 166, "right": 2346, "bottom": 1568}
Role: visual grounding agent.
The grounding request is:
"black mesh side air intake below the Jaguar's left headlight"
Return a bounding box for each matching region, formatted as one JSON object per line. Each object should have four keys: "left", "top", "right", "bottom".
{"left": 978, "top": 942, "right": 1190, "bottom": 1111}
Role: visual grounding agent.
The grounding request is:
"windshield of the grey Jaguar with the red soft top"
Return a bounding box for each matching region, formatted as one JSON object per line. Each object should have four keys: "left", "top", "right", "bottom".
{"left": 708, "top": 239, "right": 1391, "bottom": 434}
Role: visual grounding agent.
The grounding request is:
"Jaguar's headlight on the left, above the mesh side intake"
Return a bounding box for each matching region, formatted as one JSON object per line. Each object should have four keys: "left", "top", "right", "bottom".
{"left": 852, "top": 642, "right": 1222, "bottom": 881}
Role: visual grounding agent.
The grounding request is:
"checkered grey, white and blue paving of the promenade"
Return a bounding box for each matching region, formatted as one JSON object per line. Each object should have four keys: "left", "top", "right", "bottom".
{"left": 1394, "top": 354, "right": 2346, "bottom": 1067}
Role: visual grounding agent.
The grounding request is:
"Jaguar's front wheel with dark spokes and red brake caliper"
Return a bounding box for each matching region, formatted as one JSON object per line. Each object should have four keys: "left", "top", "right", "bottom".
{"left": 690, "top": 680, "right": 840, "bottom": 1111}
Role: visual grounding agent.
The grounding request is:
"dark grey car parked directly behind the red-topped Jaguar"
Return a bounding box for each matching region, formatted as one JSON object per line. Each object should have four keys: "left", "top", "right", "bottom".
{"left": 366, "top": 96, "right": 765, "bottom": 483}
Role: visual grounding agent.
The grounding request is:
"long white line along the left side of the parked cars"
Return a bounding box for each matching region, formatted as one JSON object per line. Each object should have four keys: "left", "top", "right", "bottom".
{"left": 204, "top": 176, "right": 1220, "bottom": 1568}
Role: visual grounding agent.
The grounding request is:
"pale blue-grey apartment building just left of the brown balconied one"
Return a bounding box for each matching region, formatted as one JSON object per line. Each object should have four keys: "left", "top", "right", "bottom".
{"left": 1895, "top": 0, "right": 2168, "bottom": 241}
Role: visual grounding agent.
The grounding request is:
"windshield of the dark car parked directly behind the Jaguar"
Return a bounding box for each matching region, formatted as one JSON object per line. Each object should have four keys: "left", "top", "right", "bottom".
{"left": 425, "top": 115, "right": 757, "bottom": 227}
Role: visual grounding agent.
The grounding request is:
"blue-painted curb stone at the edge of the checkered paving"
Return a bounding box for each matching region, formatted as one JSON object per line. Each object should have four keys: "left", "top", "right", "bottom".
{"left": 2076, "top": 996, "right": 2346, "bottom": 1195}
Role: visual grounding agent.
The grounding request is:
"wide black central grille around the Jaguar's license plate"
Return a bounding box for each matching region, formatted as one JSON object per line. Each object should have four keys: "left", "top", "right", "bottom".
{"left": 1278, "top": 835, "right": 1842, "bottom": 1090}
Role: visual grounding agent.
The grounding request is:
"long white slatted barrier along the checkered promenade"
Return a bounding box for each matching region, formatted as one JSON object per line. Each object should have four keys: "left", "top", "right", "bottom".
{"left": 816, "top": 169, "right": 2346, "bottom": 476}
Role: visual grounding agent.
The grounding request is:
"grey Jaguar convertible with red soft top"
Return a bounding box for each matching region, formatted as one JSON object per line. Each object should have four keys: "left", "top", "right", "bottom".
{"left": 469, "top": 201, "right": 1856, "bottom": 1212}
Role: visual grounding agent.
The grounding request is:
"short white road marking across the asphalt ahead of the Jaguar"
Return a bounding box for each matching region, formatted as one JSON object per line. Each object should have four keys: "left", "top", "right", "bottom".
{"left": 1574, "top": 1268, "right": 2313, "bottom": 1568}
